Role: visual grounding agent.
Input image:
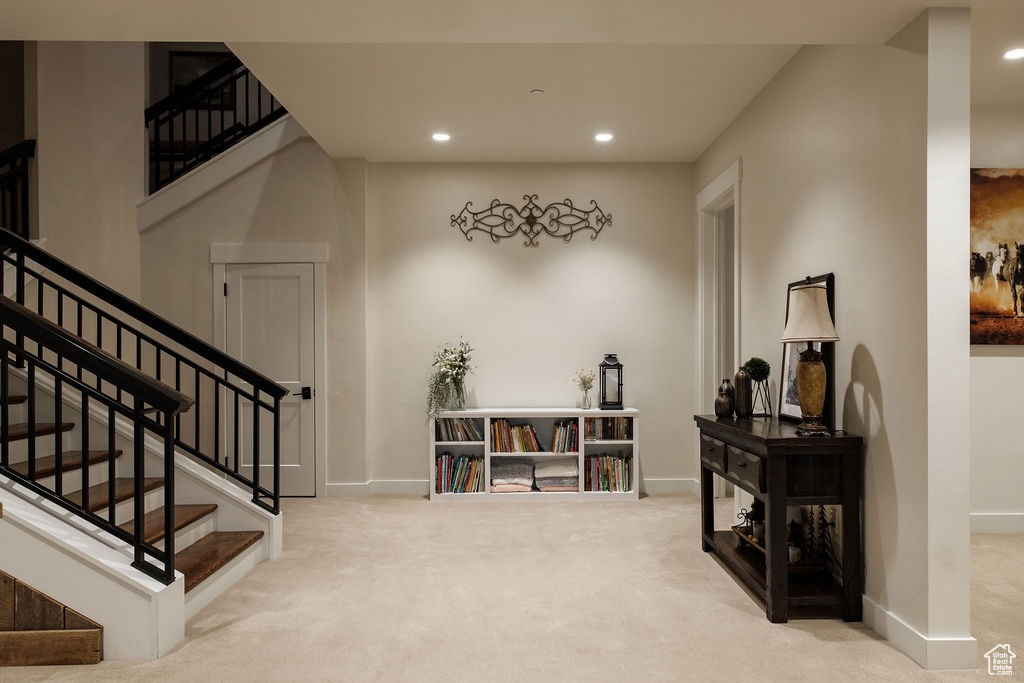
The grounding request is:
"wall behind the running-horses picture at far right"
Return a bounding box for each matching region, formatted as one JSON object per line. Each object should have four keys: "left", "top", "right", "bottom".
{"left": 971, "top": 105, "right": 1024, "bottom": 533}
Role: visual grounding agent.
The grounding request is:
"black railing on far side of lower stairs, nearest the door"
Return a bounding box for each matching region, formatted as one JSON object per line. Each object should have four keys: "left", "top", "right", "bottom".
{"left": 0, "top": 230, "right": 287, "bottom": 514}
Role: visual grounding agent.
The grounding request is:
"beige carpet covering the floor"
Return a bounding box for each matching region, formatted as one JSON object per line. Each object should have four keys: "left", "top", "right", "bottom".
{"left": 0, "top": 497, "right": 1024, "bottom": 682}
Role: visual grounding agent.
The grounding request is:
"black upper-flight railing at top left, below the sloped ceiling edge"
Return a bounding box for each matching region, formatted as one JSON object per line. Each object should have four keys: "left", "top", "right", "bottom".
{"left": 145, "top": 55, "right": 288, "bottom": 193}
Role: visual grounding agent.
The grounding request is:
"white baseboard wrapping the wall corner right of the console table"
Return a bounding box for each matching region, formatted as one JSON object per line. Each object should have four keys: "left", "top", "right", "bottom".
{"left": 863, "top": 595, "right": 978, "bottom": 671}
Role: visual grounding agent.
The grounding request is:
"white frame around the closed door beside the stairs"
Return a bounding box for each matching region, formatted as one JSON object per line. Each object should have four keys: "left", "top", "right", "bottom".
{"left": 210, "top": 244, "right": 330, "bottom": 498}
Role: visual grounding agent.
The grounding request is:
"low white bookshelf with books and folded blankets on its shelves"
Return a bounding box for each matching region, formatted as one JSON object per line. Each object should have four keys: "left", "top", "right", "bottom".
{"left": 427, "top": 408, "right": 640, "bottom": 501}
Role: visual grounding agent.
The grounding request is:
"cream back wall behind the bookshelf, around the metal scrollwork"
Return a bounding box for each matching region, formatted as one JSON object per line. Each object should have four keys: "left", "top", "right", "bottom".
{"left": 367, "top": 164, "right": 696, "bottom": 490}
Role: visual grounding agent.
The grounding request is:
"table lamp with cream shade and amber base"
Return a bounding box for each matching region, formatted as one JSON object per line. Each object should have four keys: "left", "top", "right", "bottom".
{"left": 782, "top": 279, "right": 839, "bottom": 436}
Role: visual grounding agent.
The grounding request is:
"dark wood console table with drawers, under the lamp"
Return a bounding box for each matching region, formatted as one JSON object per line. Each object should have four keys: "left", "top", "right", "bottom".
{"left": 693, "top": 415, "right": 864, "bottom": 623}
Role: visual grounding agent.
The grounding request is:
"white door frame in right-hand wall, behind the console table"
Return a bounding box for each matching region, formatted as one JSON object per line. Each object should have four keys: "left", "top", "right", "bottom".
{"left": 694, "top": 159, "right": 741, "bottom": 497}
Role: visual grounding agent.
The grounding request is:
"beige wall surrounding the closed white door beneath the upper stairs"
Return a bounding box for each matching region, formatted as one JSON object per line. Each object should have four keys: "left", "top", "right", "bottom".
{"left": 141, "top": 137, "right": 366, "bottom": 491}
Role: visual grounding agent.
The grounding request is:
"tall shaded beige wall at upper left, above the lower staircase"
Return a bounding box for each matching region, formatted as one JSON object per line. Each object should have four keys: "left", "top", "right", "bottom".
{"left": 34, "top": 42, "right": 145, "bottom": 298}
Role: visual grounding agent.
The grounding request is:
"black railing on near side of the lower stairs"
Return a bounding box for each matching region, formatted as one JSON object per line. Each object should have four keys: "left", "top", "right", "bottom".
{"left": 0, "top": 297, "right": 191, "bottom": 584}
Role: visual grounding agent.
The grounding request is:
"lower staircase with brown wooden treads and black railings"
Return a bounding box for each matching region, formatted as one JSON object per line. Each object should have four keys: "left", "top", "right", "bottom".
{"left": 0, "top": 230, "right": 285, "bottom": 658}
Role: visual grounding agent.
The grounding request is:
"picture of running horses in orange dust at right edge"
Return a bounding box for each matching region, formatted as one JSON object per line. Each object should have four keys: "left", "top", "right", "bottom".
{"left": 971, "top": 168, "right": 1024, "bottom": 344}
